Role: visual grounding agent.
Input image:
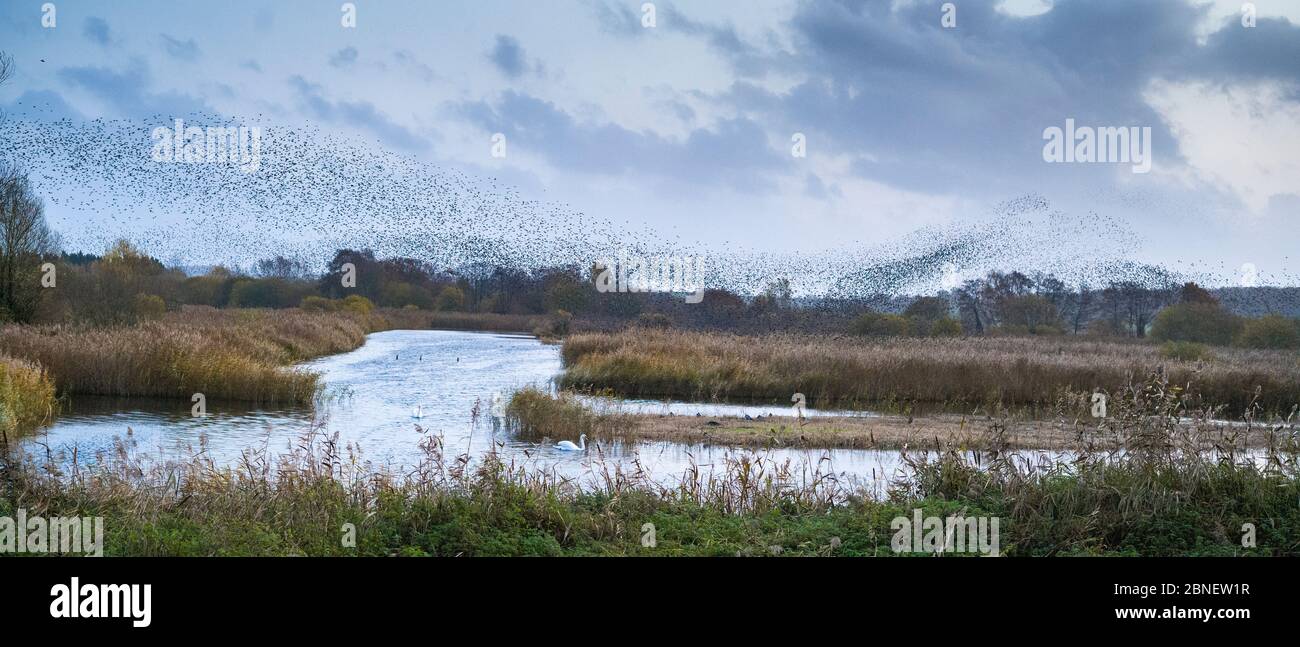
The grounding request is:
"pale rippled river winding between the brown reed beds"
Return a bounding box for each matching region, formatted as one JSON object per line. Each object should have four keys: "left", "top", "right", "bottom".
{"left": 25, "top": 330, "right": 1060, "bottom": 491}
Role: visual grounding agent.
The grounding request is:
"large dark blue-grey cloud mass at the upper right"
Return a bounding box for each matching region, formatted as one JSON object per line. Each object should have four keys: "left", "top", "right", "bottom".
{"left": 675, "top": 0, "right": 1237, "bottom": 194}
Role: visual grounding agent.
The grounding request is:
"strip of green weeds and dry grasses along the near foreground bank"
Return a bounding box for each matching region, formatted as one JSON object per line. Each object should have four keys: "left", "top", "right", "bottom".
{"left": 0, "top": 378, "right": 1300, "bottom": 556}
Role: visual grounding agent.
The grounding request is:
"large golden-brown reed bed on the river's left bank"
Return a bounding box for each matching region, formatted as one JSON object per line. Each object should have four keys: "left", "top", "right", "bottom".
{"left": 0, "top": 308, "right": 373, "bottom": 404}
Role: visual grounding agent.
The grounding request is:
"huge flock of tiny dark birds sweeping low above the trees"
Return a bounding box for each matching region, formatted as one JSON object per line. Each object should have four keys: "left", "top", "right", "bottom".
{"left": 0, "top": 114, "right": 1289, "bottom": 300}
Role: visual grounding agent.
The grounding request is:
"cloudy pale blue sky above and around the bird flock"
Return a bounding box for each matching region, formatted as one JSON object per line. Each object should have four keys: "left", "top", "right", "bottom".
{"left": 0, "top": 0, "right": 1300, "bottom": 285}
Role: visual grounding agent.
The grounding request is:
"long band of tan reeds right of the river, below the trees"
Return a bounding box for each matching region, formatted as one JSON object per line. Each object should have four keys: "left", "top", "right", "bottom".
{"left": 563, "top": 329, "right": 1300, "bottom": 414}
